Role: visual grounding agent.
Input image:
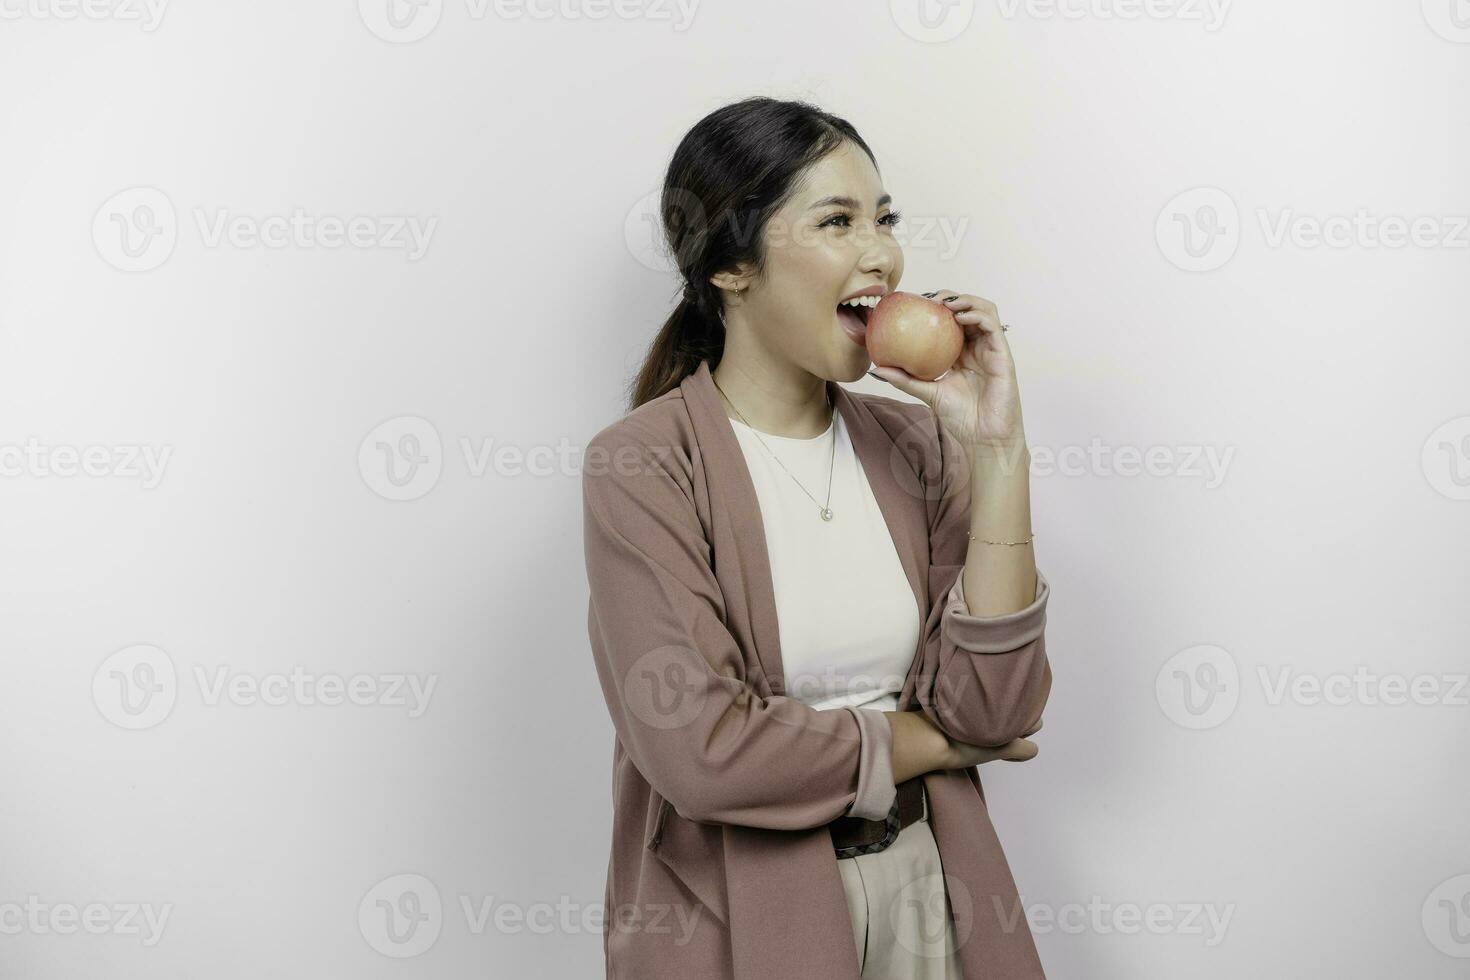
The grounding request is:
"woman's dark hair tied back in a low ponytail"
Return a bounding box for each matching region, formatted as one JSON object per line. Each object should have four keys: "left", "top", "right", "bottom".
{"left": 628, "top": 96, "right": 878, "bottom": 411}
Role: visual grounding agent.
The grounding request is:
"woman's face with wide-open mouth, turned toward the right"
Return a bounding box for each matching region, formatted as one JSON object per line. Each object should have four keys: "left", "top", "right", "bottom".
{"left": 725, "top": 141, "right": 904, "bottom": 381}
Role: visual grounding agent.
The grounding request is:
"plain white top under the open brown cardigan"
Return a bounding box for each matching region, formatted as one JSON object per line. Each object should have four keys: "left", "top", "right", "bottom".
{"left": 731, "top": 411, "right": 922, "bottom": 711}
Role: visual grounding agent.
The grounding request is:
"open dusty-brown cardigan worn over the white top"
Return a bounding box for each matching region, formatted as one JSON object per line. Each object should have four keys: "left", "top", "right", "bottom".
{"left": 582, "top": 361, "right": 1051, "bottom": 980}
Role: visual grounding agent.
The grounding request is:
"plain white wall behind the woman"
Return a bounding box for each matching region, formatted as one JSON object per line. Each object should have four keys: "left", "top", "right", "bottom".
{"left": 0, "top": 0, "right": 1470, "bottom": 980}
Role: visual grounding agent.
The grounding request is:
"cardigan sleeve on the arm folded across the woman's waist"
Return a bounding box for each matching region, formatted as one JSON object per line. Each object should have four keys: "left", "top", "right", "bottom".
{"left": 582, "top": 419, "right": 897, "bottom": 830}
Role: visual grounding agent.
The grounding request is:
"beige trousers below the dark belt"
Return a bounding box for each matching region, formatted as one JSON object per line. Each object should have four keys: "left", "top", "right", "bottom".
{"left": 836, "top": 793, "right": 963, "bottom": 980}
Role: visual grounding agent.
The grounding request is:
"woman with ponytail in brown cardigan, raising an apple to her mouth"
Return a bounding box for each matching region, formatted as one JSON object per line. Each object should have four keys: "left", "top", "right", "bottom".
{"left": 582, "top": 98, "right": 1051, "bottom": 980}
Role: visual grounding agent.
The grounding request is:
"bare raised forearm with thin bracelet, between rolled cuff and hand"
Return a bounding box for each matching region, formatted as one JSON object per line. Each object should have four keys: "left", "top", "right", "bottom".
{"left": 963, "top": 442, "right": 1036, "bottom": 616}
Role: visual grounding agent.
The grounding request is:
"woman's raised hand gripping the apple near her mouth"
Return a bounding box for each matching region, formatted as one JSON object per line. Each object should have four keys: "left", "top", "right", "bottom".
{"left": 873, "top": 289, "right": 1026, "bottom": 453}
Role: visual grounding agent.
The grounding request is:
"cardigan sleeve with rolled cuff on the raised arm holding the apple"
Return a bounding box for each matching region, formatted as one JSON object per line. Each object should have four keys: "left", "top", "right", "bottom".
{"left": 919, "top": 407, "right": 1051, "bottom": 746}
